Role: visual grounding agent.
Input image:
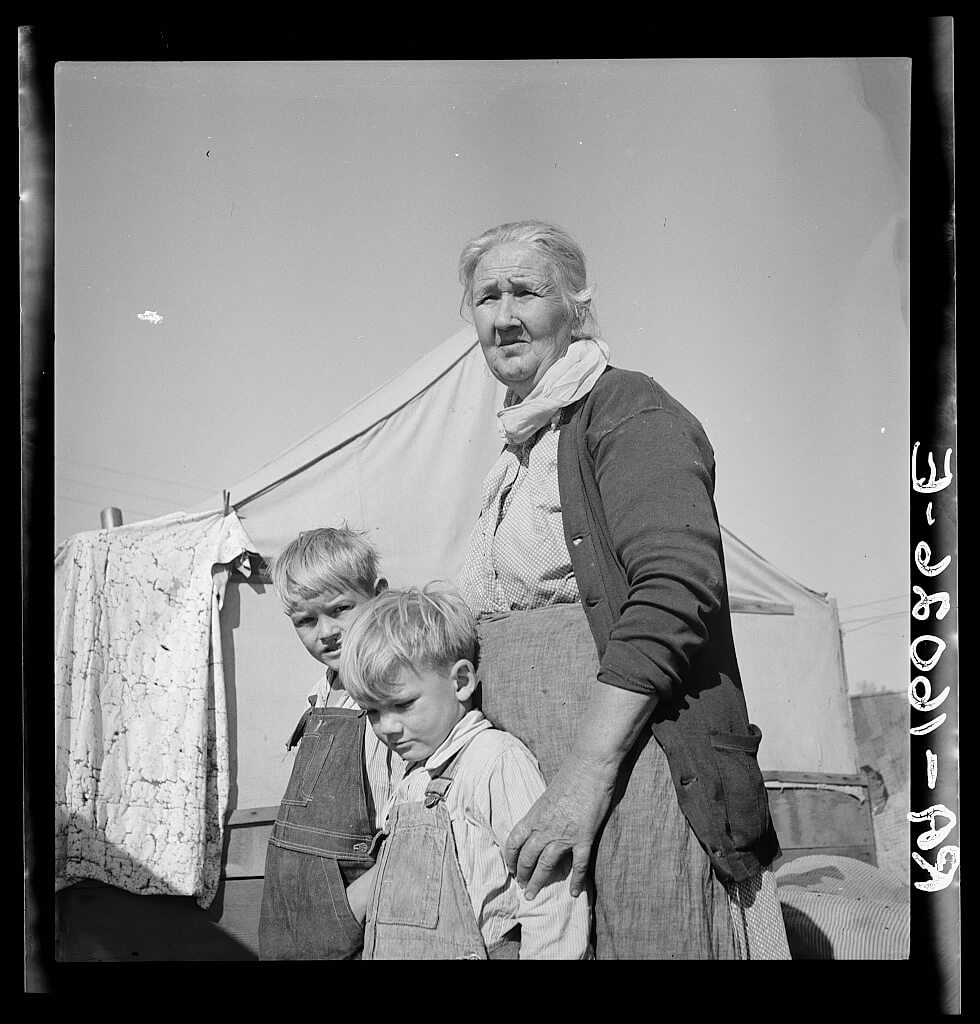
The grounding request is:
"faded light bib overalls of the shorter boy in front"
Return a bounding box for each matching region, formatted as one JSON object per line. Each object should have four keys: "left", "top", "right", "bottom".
{"left": 364, "top": 748, "right": 520, "bottom": 959}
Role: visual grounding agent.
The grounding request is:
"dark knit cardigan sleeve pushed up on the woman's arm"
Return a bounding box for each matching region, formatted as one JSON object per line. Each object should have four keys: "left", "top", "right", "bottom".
{"left": 589, "top": 407, "right": 725, "bottom": 700}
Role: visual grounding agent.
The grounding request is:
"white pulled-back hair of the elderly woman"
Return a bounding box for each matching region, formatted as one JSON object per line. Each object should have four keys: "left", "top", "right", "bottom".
{"left": 459, "top": 220, "right": 599, "bottom": 339}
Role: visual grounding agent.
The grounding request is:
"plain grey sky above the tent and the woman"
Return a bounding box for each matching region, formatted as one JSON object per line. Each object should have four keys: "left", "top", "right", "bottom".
{"left": 54, "top": 58, "right": 910, "bottom": 689}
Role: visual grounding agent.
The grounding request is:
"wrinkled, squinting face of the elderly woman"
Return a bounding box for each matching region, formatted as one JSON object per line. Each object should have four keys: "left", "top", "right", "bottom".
{"left": 472, "top": 243, "right": 572, "bottom": 398}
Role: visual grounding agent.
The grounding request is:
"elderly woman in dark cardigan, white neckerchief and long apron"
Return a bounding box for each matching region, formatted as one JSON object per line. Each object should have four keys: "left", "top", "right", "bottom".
{"left": 458, "top": 221, "right": 790, "bottom": 959}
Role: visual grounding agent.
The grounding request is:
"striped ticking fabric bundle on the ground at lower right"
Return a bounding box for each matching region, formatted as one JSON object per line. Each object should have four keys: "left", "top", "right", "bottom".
{"left": 775, "top": 854, "right": 910, "bottom": 959}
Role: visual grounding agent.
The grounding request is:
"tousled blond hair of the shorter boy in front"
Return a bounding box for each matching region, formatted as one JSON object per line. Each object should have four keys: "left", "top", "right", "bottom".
{"left": 340, "top": 584, "right": 477, "bottom": 702}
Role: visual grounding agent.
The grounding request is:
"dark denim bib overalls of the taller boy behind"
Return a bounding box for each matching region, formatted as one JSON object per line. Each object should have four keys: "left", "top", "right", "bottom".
{"left": 259, "top": 697, "right": 377, "bottom": 959}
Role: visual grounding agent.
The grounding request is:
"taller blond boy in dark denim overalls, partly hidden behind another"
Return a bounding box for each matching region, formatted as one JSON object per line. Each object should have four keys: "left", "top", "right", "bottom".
{"left": 259, "top": 528, "right": 403, "bottom": 959}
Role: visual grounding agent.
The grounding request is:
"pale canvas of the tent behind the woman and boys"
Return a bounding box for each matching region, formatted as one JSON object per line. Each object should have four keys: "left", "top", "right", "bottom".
{"left": 199, "top": 328, "right": 858, "bottom": 807}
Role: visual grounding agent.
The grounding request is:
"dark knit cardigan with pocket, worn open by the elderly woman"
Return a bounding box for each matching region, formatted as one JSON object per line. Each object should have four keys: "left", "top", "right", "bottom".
{"left": 558, "top": 367, "right": 779, "bottom": 882}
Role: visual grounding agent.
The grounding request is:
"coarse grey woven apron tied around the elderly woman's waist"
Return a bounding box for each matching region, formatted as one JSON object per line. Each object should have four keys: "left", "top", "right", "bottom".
{"left": 477, "top": 603, "right": 737, "bottom": 959}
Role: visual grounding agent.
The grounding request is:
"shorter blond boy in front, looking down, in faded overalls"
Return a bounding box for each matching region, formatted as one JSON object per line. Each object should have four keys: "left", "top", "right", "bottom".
{"left": 340, "top": 587, "right": 589, "bottom": 959}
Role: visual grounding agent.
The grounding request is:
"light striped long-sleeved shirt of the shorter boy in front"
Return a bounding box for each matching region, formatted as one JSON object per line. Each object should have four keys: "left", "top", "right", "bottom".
{"left": 376, "top": 711, "right": 590, "bottom": 959}
